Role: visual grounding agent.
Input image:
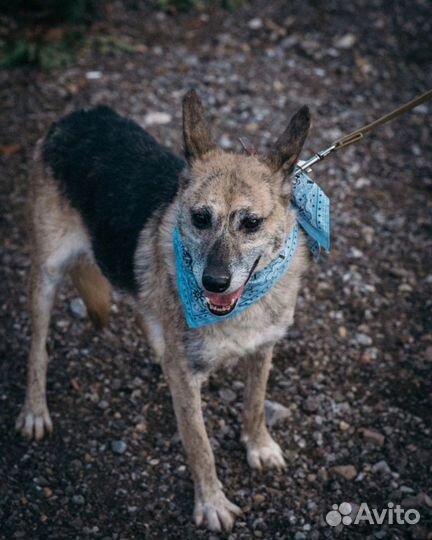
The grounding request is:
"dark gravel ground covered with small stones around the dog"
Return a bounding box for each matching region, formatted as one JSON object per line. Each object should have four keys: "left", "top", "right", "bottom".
{"left": 0, "top": 0, "right": 432, "bottom": 540}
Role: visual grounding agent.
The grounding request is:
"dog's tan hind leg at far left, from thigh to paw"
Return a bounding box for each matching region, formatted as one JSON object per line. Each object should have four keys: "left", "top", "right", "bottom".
{"left": 16, "top": 154, "right": 89, "bottom": 440}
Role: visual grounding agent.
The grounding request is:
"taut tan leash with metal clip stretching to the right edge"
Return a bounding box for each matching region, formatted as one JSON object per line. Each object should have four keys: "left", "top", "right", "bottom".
{"left": 297, "top": 90, "right": 432, "bottom": 172}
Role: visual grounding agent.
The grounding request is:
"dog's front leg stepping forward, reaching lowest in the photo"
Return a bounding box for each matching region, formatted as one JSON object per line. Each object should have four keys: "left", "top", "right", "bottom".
{"left": 163, "top": 352, "right": 241, "bottom": 531}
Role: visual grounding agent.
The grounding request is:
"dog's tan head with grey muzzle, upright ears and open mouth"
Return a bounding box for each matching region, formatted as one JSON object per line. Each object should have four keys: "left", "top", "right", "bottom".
{"left": 179, "top": 90, "right": 310, "bottom": 315}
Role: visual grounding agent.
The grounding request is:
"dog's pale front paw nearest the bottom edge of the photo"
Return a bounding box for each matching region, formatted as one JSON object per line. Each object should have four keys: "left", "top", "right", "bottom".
{"left": 194, "top": 490, "right": 242, "bottom": 532}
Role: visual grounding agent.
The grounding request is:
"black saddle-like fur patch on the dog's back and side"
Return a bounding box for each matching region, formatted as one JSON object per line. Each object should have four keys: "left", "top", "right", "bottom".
{"left": 43, "top": 107, "right": 185, "bottom": 293}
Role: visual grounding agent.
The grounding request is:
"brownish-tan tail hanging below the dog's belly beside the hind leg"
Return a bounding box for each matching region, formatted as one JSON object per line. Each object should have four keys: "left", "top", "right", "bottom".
{"left": 71, "top": 259, "right": 111, "bottom": 330}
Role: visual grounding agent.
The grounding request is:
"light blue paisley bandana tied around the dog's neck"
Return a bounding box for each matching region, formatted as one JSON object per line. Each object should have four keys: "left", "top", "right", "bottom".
{"left": 173, "top": 169, "right": 330, "bottom": 328}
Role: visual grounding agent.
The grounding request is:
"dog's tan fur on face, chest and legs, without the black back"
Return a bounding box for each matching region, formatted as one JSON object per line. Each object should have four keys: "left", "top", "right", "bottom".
{"left": 17, "top": 98, "right": 309, "bottom": 531}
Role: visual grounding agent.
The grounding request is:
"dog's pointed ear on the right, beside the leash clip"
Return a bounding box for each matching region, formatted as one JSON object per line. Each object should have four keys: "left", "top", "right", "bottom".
{"left": 263, "top": 105, "right": 310, "bottom": 173}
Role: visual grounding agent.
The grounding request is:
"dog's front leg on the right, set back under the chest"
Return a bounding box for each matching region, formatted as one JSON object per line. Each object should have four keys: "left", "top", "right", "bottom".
{"left": 242, "top": 346, "right": 285, "bottom": 469}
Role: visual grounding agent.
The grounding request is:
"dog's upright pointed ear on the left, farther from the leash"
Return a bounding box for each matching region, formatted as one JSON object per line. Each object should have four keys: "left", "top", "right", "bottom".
{"left": 183, "top": 90, "right": 216, "bottom": 162}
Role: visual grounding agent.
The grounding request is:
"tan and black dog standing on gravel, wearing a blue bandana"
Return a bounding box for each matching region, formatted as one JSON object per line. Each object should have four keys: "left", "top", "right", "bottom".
{"left": 16, "top": 90, "right": 310, "bottom": 531}
